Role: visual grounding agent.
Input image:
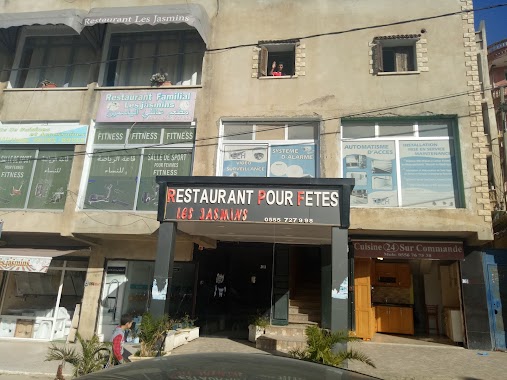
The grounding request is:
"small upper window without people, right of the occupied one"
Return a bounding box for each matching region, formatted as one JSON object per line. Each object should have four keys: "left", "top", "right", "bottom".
{"left": 372, "top": 34, "right": 420, "bottom": 75}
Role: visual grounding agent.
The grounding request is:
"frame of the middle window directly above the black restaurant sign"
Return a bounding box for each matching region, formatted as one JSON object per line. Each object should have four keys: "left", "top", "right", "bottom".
{"left": 215, "top": 119, "right": 320, "bottom": 178}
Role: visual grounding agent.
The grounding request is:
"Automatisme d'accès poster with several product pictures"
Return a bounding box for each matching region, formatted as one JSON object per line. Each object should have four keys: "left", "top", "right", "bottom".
{"left": 343, "top": 141, "right": 398, "bottom": 207}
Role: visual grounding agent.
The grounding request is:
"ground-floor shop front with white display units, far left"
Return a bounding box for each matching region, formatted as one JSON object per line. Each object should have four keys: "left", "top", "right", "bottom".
{"left": 0, "top": 248, "right": 88, "bottom": 341}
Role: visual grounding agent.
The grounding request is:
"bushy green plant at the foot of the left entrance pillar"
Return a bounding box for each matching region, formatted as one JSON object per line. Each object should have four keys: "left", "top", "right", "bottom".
{"left": 129, "top": 313, "right": 170, "bottom": 361}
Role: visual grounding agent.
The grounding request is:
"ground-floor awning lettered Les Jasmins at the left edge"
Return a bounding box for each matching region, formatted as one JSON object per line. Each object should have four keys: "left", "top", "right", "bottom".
{"left": 0, "top": 248, "right": 76, "bottom": 273}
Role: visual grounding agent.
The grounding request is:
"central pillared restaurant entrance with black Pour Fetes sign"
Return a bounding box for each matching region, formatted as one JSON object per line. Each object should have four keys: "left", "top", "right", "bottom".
{"left": 151, "top": 177, "right": 354, "bottom": 337}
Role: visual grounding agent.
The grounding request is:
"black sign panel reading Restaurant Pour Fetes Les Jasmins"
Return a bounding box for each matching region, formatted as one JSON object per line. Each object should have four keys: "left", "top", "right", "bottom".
{"left": 164, "top": 186, "right": 340, "bottom": 226}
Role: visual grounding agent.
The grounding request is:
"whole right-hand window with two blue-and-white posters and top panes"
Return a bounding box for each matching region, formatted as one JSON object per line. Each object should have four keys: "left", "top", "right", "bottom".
{"left": 341, "top": 119, "right": 460, "bottom": 208}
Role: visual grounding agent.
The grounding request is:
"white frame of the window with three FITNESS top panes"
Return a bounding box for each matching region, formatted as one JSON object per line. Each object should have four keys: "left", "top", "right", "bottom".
{"left": 80, "top": 120, "right": 197, "bottom": 214}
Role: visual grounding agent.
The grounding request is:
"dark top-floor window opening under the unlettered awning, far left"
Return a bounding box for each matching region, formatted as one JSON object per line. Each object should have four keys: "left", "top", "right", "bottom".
{"left": 11, "top": 27, "right": 96, "bottom": 88}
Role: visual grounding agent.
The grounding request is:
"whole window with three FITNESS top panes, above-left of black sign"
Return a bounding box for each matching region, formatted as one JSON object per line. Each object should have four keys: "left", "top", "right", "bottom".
{"left": 83, "top": 125, "right": 195, "bottom": 211}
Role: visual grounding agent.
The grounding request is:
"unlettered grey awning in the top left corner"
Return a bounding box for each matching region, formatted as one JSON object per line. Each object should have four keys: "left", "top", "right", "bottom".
{"left": 0, "top": 9, "right": 88, "bottom": 33}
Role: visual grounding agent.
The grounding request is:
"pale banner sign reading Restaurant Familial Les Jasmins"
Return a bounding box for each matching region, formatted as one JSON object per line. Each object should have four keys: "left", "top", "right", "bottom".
{"left": 96, "top": 89, "right": 197, "bottom": 123}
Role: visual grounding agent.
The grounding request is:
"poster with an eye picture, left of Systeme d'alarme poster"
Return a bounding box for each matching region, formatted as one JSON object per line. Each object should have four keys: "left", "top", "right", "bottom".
{"left": 222, "top": 145, "right": 268, "bottom": 177}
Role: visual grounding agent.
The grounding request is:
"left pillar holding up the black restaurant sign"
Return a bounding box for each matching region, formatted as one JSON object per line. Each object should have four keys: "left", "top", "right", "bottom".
{"left": 150, "top": 222, "right": 176, "bottom": 317}
